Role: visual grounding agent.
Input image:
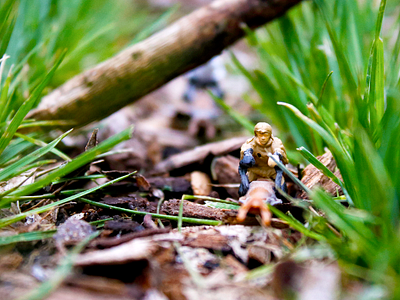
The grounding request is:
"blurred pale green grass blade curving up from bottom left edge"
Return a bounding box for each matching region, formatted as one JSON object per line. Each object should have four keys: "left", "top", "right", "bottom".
{"left": 19, "top": 231, "right": 100, "bottom": 300}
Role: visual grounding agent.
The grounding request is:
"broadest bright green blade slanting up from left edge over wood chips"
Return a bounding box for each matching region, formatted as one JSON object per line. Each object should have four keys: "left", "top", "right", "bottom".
{"left": 0, "top": 126, "right": 133, "bottom": 203}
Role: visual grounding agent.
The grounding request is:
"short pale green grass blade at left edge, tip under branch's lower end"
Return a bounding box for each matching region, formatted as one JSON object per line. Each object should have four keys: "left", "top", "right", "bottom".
{"left": 0, "top": 129, "right": 72, "bottom": 181}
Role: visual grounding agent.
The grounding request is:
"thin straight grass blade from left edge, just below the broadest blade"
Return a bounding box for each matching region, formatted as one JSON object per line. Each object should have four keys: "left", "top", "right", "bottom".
{"left": 0, "top": 172, "right": 136, "bottom": 228}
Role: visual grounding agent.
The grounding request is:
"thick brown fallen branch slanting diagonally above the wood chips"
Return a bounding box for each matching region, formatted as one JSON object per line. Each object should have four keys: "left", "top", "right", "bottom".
{"left": 28, "top": 0, "right": 301, "bottom": 127}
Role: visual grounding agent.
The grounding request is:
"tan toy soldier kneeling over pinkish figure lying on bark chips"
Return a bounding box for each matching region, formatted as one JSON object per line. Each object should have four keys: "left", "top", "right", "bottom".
{"left": 238, "top": 122, "right": 289, "bottom": 225}
